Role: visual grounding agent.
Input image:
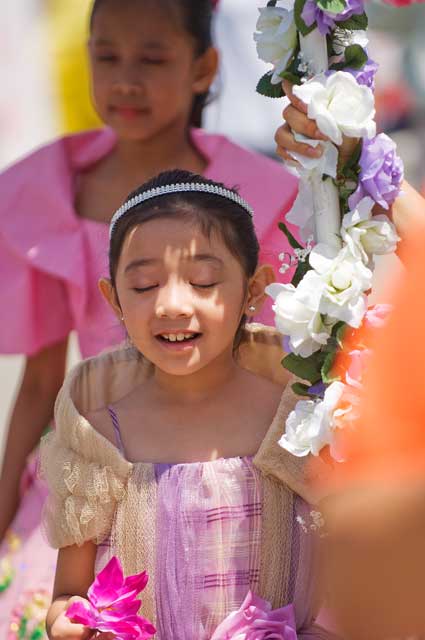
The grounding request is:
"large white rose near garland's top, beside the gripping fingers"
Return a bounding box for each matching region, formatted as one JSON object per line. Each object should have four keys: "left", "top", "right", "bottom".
{"left": 293, "top": 71, "right": 376, "bottom": 145}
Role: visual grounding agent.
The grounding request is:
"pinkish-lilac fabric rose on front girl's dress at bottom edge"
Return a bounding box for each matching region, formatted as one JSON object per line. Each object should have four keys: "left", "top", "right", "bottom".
{"left": 211, "top": 591, "right": 297, "bottom": 640}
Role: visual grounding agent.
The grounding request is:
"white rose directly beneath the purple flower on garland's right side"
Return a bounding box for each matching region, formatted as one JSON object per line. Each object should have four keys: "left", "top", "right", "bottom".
{"left": 341, "top": 197, "right": 400, "bottom": 264}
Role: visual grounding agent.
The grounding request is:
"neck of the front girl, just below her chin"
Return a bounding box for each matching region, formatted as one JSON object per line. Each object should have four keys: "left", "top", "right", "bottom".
{"left": 153, "top": 352, "right": 239, "bottom": 404}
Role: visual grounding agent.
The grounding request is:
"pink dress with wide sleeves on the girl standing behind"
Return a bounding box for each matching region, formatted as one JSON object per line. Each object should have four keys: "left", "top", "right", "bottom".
{"left": 0, "top": 129, "right": 297, "bottom": 639}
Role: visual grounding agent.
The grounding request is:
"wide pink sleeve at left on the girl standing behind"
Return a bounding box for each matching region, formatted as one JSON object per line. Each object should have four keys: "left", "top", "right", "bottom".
{"left": 0, "top": 141, "right": 79, "bottom": 355}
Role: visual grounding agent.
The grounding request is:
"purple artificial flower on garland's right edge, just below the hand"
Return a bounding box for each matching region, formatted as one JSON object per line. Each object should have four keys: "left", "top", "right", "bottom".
{"left": 348, "top": 133, "right": 403, "bottom": 210}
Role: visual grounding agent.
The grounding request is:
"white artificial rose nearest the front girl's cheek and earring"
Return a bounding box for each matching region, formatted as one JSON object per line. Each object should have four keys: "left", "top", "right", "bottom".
{"left": 266, "top": 283, "right": 332, "bottom": 358}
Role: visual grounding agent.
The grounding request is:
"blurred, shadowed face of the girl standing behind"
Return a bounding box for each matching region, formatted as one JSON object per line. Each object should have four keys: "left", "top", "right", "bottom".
{"left": 89, "top": 0, "right": 216, "bottom": 141}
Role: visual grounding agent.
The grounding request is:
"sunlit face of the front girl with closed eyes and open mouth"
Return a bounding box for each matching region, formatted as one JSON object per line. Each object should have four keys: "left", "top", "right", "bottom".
{"left": 107, "top": 218, "right": 246, "bottom": 375}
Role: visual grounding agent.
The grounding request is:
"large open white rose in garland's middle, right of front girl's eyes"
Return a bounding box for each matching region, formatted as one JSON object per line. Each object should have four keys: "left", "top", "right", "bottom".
{"left": 296, "top": 244, "right": 372, "bottom": 328}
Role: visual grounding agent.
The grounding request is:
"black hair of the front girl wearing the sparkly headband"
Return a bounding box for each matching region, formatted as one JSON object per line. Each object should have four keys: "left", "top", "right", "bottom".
{"left": 109, "top": 169, "right": 260, "bottom": 349}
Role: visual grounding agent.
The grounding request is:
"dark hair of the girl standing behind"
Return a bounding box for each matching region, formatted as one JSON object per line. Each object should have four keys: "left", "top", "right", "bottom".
{"left": 90, "top": 0, "right": 213, "bottom": 127}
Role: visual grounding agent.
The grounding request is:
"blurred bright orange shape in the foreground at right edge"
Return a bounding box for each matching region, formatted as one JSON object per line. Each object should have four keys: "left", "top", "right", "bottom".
{"left": 337, "top": 221, "right": 425, "bottom": 485}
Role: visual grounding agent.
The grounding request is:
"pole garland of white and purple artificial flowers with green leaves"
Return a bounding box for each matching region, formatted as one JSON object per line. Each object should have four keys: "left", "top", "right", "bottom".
{"left": 254, "top": 0, "right": 403, "bottom": 460}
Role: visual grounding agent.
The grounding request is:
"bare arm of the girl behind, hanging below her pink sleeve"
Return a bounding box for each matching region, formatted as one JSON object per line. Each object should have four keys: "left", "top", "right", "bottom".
{"left": 0, "top": 339, "right": 68, "bottom": 540}
